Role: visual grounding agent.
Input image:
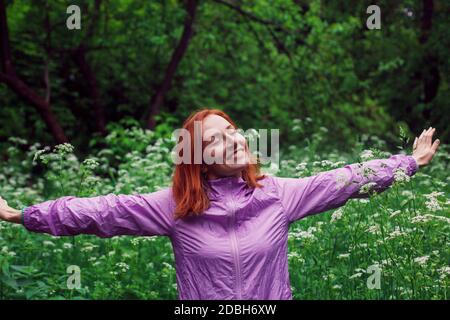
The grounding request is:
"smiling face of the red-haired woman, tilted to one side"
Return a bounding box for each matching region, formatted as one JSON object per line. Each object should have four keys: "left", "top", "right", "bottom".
{"left": 202, "top": 115, "right": 249, "bottom": 179}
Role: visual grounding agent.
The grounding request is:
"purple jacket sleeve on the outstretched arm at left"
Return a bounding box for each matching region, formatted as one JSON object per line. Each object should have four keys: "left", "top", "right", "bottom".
{"left": 22, "top": 188, "right": 175, "bottom": 238}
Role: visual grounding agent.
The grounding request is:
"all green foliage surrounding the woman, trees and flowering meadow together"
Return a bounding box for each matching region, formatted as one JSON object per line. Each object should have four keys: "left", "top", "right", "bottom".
{"left": 0, "top": 0, "right": 450, "bottom": 299}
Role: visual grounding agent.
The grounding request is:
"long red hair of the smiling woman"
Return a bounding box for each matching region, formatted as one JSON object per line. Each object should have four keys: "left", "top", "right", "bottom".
{"left": 172, "top": 109, "right": 264, "bottom": 218}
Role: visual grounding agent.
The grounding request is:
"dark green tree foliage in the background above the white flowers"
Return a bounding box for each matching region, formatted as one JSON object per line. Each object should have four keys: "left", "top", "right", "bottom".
{"left": 0, "top": 0, "right": 450, "bottom": 148}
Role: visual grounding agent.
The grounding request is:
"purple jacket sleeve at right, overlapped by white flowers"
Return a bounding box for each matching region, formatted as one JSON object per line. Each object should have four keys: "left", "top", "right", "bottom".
{"left": 273, "top": 154, "right": 418, "bottom": 223}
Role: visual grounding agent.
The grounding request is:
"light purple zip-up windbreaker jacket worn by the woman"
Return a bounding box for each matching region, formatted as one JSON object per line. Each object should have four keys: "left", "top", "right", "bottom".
{"left": 23, "top": 155, "right": 418, "bottom": 300}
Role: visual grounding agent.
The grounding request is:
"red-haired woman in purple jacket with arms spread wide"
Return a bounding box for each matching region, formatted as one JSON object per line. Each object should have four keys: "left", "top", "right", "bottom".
{"left": 0, "top": 109, "right": 439, "bottom": 299}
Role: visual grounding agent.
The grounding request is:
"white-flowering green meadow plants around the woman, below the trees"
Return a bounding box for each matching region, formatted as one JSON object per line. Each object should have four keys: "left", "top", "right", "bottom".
{"left": 0, "top": 126, "right": 450, "bottom": 299}
